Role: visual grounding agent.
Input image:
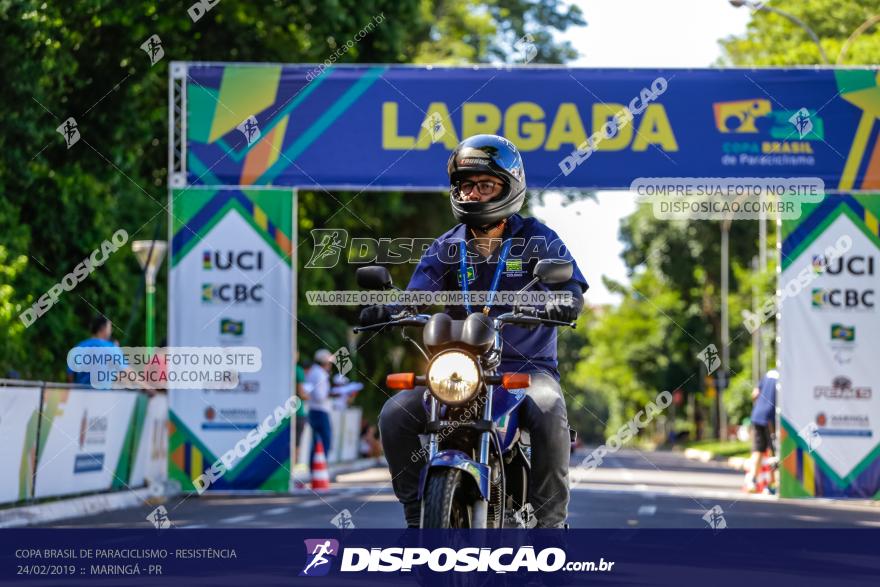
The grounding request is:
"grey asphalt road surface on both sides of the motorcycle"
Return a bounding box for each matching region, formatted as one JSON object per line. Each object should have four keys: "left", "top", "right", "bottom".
{"left": 41, "top": 450, "right": 880, "bottom": 529}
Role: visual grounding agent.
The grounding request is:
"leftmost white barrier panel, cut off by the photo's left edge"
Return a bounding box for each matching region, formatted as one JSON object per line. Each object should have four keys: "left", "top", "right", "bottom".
{"left": 0, "top": 387, "right": 40, "bottom": 503}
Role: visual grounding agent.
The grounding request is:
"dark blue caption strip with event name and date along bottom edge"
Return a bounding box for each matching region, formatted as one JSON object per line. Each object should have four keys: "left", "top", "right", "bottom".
{"left": 0, "top": 532, "right": 880, "bottom": 587}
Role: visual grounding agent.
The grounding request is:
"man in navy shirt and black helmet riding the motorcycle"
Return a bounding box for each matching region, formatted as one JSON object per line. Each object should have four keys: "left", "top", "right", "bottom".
{"left": 360, "top": 135, "right": 588, "bottom": 528}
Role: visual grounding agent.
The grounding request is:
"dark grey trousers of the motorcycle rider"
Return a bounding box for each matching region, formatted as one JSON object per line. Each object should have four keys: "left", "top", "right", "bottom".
{"left": 379, "top": 372, "right": 571, "bottom": 528}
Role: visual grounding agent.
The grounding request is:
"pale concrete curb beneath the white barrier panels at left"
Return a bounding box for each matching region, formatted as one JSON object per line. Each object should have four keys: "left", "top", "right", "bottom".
{"left": 0, "top": 487, "right": 161, "bottom": 528}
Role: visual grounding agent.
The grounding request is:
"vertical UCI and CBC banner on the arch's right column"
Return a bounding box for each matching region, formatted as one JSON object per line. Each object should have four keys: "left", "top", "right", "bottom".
{"left": 779, "top": 195, "right": 880, "bottom": 499}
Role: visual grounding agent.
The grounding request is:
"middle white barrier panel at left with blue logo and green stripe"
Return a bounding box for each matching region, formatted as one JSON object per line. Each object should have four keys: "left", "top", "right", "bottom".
{"left": 34, "top": 388, "right": 140, "bottom": 498}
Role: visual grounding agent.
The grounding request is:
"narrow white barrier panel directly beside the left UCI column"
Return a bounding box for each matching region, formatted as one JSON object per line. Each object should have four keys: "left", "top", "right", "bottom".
{"left": 129, "top": 393, "right": 168, "bottom": 487}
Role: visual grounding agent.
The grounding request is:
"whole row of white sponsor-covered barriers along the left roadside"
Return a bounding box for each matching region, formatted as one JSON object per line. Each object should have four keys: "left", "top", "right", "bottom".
{"left": 0, "top": 379, "right": 168, "bottom": 505}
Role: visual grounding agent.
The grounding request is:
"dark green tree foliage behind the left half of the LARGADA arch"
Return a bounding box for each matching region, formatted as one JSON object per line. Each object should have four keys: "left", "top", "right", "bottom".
{"left": 0, "top": 0, "right": 582, "bottom": 411}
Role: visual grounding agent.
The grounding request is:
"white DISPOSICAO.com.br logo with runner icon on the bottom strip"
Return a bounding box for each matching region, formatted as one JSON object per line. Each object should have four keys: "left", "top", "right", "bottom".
{"left": 300, "top": 538, "right": 614, "bottom": 577}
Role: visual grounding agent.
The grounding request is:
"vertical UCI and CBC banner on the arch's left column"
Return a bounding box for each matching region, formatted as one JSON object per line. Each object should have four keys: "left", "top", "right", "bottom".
{"left": 168, "top": 188, "right": 296, "bottom": 492}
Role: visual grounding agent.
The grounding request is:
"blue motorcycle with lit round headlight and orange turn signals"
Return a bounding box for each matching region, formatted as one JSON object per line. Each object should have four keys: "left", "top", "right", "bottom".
{"left": 354, "top": 259, "right": 575, "bottom": 528}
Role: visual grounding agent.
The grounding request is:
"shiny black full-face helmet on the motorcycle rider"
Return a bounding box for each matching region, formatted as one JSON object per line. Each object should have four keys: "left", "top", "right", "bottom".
{"left": 447, "top": 135, "right": 526, "bottom": 227}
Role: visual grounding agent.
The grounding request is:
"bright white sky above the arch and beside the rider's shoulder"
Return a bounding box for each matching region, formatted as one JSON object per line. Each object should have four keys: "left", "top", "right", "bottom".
{"left": 526, "top": 0, "right": 750, "bottom": 305}
